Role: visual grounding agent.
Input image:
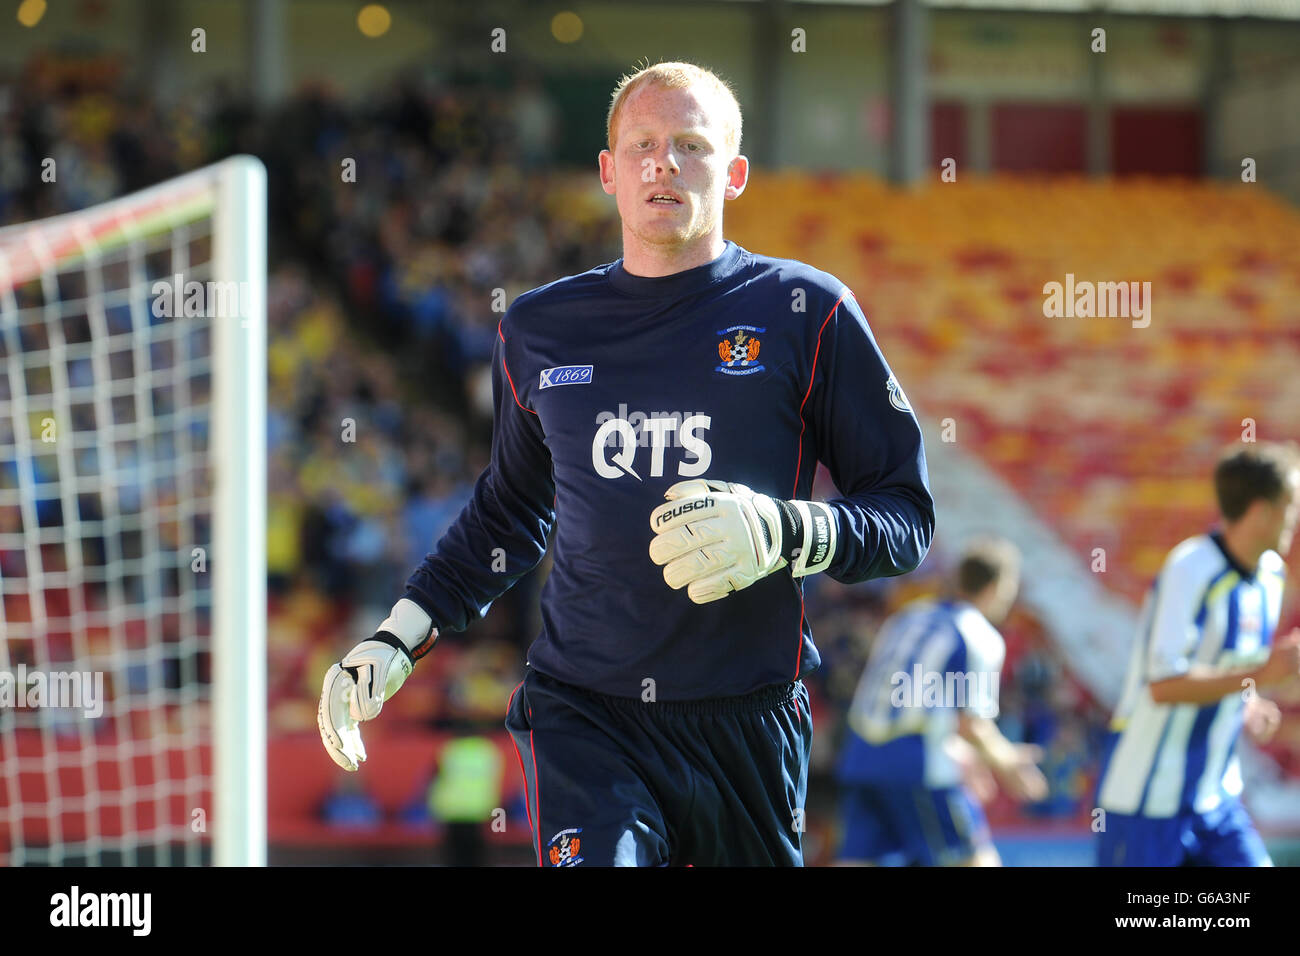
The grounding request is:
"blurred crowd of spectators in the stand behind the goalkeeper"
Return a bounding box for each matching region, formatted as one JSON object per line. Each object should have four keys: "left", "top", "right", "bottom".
{"left": 0, "top": 61, "right": 1104, "bottom": 842}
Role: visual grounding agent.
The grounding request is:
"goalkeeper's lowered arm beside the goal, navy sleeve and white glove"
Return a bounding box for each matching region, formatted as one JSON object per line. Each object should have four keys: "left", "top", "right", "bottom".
{"left": 316, "top": 323, "right": 555, "bottom": 770}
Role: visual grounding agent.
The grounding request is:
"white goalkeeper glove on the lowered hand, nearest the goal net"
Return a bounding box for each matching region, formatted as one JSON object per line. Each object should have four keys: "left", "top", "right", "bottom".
{"left": 316, "top": 597, "right": 438, "bottom": 770}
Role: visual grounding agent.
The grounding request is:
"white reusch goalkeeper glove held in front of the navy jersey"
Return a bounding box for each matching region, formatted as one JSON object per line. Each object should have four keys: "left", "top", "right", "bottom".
{"left": 650, "top": 479, "right": 836, "bottom": 604}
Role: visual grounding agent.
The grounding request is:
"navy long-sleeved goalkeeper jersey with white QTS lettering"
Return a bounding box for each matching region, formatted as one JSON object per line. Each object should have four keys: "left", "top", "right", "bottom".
{"left": 406, "top": 241, "right": 935, "bottom": 700}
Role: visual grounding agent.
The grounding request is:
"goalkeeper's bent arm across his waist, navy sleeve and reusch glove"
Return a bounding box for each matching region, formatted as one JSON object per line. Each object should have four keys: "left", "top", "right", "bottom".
{"left": 650, "top": 290, "right": 935, "bottom": 604}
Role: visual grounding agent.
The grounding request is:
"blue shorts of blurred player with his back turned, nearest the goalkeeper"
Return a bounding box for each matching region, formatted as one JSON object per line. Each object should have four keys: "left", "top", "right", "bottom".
{"left": 839, "top": 784, "right": 993, "bottom": 866}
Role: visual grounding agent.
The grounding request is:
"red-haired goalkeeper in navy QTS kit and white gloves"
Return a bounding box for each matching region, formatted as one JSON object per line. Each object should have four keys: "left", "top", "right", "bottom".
{"left": 319, "top": 64, "right": 935, "bottom": 866}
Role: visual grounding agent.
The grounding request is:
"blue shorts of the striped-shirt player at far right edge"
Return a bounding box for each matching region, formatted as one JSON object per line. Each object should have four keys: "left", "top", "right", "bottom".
{"left": 1097, "top": 799, "right": 1273, "bottom": 866}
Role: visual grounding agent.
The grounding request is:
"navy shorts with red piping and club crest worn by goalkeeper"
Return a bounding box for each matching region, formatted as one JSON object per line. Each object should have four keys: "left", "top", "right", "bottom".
{"left": 506, "top": 669, "right": 813, "bottom": 866}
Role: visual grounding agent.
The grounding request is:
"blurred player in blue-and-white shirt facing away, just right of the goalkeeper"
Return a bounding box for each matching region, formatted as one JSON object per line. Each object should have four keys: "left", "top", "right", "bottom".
{"left": 837, "top": 540, "right": 1048, "bottom": 866}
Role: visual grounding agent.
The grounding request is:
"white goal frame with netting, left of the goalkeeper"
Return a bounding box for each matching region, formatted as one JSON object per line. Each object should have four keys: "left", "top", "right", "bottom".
{"left": 0, "top": 156, "right": 267, "bottom": 866}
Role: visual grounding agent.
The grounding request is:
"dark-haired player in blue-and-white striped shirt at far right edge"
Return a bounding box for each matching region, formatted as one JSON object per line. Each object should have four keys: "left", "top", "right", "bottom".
{"left": 1097, "top": 444, "right": 1300, "bottom": 866}
